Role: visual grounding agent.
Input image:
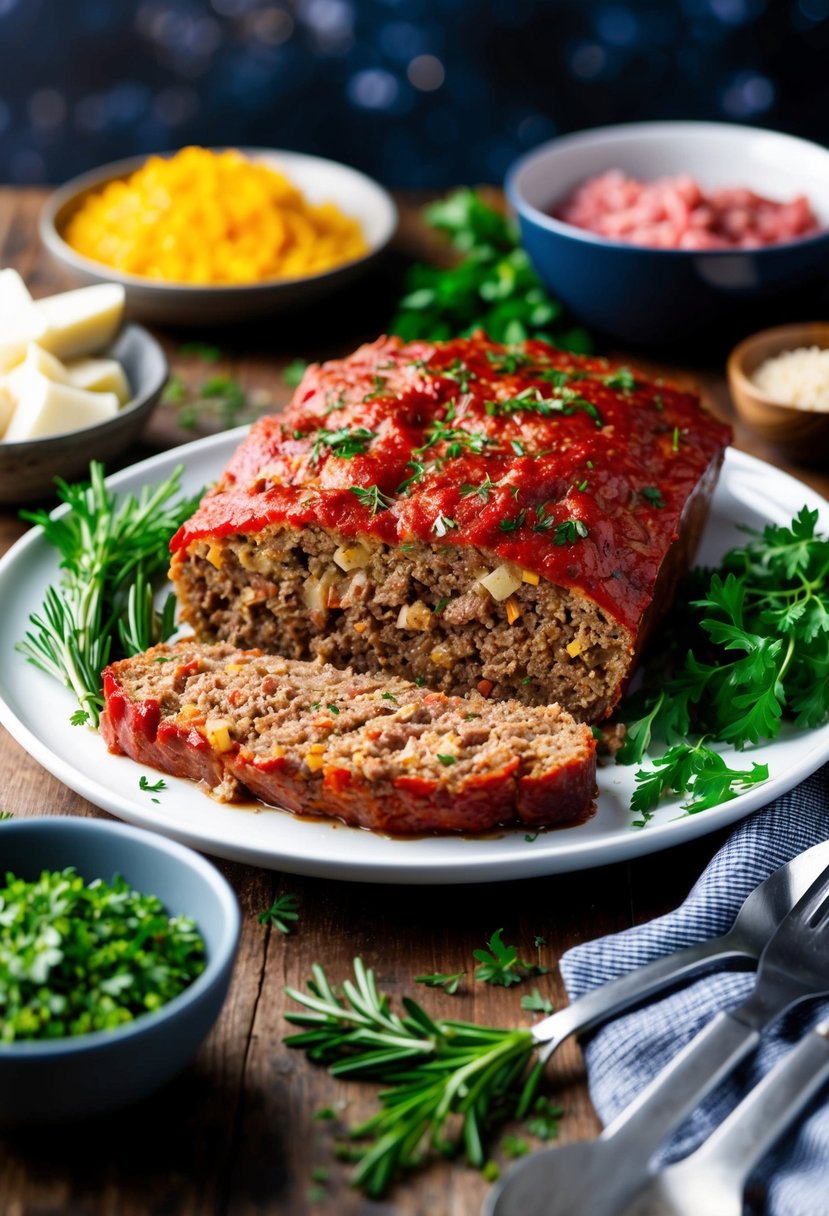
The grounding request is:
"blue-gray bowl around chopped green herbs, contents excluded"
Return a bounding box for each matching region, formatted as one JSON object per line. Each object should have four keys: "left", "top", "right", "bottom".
{"left": 0, "top": 818, "right": 239, "bottom": 1126}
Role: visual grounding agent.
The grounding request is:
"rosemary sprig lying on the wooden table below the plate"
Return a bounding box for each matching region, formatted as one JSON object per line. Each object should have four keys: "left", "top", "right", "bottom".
{"left": 286, "top": 958, "right": 543, "bottom": 1197}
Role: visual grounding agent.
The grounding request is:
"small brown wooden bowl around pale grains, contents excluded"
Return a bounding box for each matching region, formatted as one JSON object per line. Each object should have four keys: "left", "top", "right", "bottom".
{"left": 728, "top": 321, "right": 829, "bottom": 465}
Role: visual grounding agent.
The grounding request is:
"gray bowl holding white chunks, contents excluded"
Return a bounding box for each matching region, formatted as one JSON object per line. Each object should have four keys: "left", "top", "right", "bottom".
{"left": 0, "top": 325, "right": 169, "bottom": 502}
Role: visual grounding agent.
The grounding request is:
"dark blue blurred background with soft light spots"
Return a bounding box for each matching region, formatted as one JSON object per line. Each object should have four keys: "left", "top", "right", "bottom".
{"left": 0, "top": 0, "right": 829, "bottom": 187}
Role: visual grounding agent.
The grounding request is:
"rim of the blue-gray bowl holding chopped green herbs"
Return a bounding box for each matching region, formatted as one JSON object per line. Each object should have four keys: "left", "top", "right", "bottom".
{"left": 0, "top": 815, "right": 242, "bottom": 1066}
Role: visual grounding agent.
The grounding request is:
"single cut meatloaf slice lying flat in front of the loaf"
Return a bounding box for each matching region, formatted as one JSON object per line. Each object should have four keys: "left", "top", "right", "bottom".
{"left": 101, "top": 641, "right": 596, "bottom": 834}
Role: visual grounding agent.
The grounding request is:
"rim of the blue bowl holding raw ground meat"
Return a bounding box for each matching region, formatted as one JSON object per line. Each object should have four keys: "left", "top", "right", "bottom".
{"left": 503, "top": 119, "right": 829, "bottom": 259}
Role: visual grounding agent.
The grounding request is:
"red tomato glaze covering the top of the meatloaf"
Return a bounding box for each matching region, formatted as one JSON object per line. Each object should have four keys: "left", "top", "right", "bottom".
{"left": 171, "top": 336, "right": 731, "bottom": 629}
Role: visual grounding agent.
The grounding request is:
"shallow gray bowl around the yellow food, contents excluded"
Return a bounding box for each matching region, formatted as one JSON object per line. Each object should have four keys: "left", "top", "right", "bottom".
{"left": 40, "top": 148, "right": 397, "bottom": 326}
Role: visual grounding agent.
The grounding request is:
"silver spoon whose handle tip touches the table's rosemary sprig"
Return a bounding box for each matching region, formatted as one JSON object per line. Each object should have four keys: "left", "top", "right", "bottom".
{"left": 532, "top": 840, "right": 829, "bottom": 1060}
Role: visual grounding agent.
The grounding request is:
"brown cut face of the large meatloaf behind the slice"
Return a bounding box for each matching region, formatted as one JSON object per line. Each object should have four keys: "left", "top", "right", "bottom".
{"left": 174, "top": 525, "right": 633, "bottom": 721}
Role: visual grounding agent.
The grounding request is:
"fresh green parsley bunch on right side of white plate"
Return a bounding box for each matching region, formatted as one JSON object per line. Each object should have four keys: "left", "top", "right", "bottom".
{"left": 617, "top": 507, "right": 829, "bottom": 823}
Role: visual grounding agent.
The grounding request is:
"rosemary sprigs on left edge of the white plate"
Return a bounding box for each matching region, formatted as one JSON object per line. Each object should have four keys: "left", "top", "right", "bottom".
{"left": 17, "top": 461, "right": 199, "bottom": 726}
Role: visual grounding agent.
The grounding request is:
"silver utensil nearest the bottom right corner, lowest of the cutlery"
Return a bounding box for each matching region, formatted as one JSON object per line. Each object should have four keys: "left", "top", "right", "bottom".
{"left": 624, "top": 1019, "right": 829, "bottom": 1216}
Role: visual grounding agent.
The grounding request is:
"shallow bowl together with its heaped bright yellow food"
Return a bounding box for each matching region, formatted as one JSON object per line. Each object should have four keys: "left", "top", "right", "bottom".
{"left": 40, "top": 147, "right": 397, "bottom": 325}
